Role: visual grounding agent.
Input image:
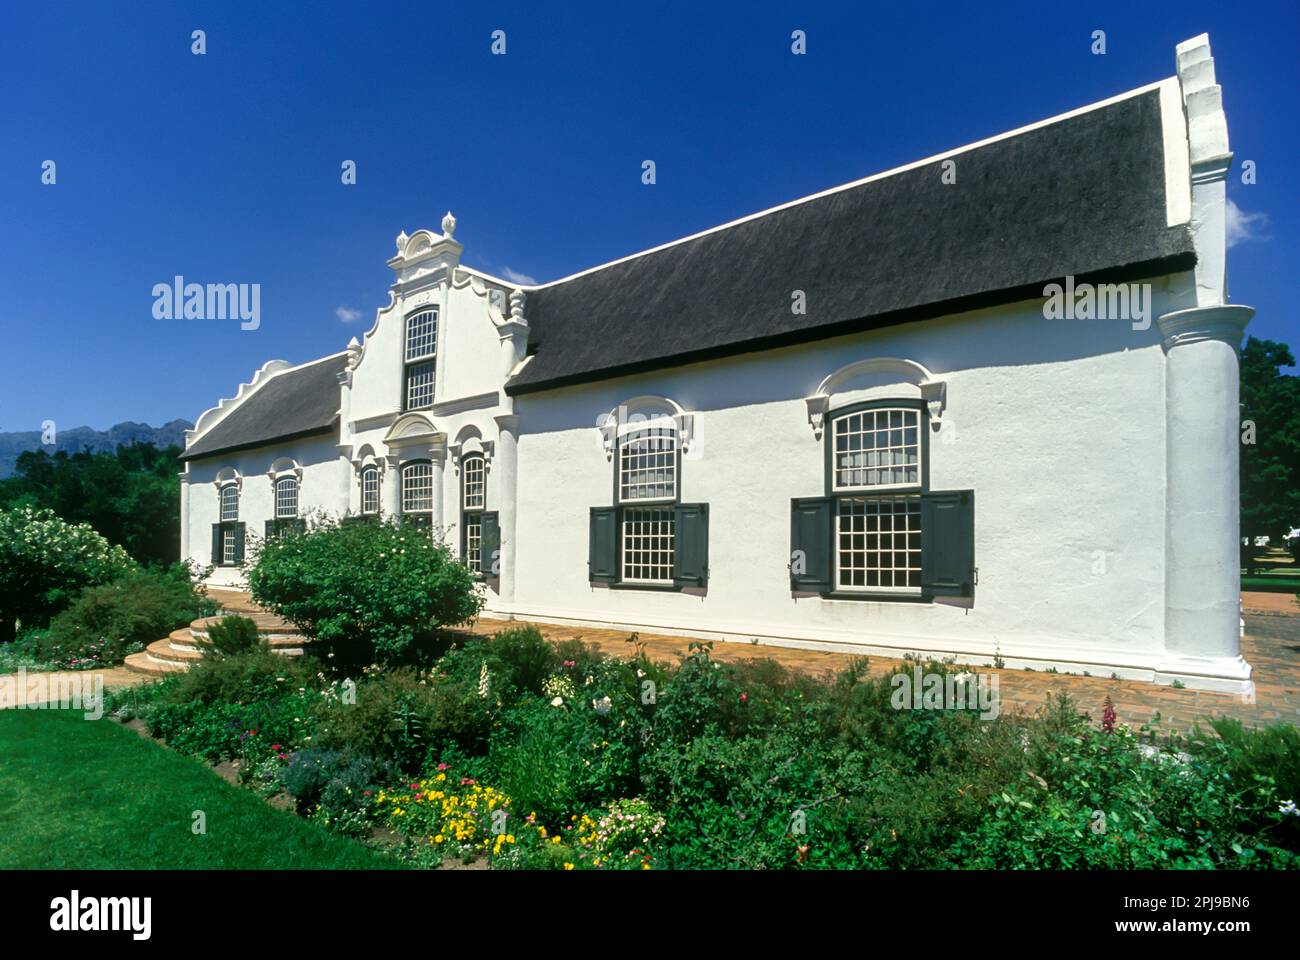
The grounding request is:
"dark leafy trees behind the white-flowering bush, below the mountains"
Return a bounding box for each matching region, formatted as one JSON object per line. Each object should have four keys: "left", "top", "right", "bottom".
{"left": 0, "top": 444, "right": 181, "bottom": 565}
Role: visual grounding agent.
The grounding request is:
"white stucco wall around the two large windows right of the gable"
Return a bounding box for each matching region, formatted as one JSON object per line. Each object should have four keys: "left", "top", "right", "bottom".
{"left": 508, "top": 276, "right": 1190, "bottom": 675}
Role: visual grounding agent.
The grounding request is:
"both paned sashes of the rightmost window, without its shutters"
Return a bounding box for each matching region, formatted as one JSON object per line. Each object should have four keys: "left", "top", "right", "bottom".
{"left": 829, "top": 406, "right": 923, "bottom": 593}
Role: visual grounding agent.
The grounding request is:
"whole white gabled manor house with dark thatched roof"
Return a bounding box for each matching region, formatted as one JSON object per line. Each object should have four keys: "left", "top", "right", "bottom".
{"left": 182, "top": 36, "right": 1252, "bottom": 691}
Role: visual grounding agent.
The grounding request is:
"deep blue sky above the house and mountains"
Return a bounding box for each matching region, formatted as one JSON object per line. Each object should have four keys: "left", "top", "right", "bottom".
{"left": 0, "top": 0, "right": 1300, "bottom": 431}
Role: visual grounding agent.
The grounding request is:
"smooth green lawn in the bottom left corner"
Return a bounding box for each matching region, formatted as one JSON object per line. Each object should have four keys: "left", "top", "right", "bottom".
{"left": 0, "top": 710, "right": 398, "bottom": 870}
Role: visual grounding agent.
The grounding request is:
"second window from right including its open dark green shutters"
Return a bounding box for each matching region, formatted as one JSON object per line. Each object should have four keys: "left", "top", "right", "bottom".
{"left": 589, "top": 416, "right": 709, "bottom": 589}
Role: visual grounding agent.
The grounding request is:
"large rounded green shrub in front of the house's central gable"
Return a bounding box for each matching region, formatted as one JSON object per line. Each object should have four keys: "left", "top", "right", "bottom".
{"left": 248, "top": 520, "right": 484, "bottom": 663}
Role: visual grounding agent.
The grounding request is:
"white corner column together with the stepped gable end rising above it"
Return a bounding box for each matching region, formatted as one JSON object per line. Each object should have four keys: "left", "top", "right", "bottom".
{"left": 1156, "top": 34, "right": 1255, "bottom": 693}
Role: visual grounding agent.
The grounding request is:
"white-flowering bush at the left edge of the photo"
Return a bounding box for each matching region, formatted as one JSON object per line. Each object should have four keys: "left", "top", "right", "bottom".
{"left": 0, "top": 506, "right": 137, "bottom": 643}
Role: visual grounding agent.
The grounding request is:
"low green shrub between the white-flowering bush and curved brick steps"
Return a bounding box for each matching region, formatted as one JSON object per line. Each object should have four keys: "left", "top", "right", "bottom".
{"left": 33, "top": 563, "right": 216, "bottom": 669}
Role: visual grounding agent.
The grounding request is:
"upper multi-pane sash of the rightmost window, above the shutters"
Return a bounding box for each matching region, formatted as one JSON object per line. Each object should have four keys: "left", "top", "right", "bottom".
{"left": 833, "top": 408, "right": 920, "bottom": 490}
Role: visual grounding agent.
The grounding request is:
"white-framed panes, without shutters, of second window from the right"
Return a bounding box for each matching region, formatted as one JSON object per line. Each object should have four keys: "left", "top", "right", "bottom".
{"left": 618, "top": 425, "right": 677, "bottom": 584}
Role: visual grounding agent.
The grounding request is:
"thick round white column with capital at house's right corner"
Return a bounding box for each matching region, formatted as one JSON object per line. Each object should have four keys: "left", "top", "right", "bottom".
{"left": 1156, "top": 304, "right": 1255, "bottom": 692}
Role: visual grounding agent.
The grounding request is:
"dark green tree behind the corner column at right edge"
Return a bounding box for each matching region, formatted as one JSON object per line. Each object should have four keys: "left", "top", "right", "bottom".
{"left": 1240, "top": 337, "right": 1300, "bottom": 545}
